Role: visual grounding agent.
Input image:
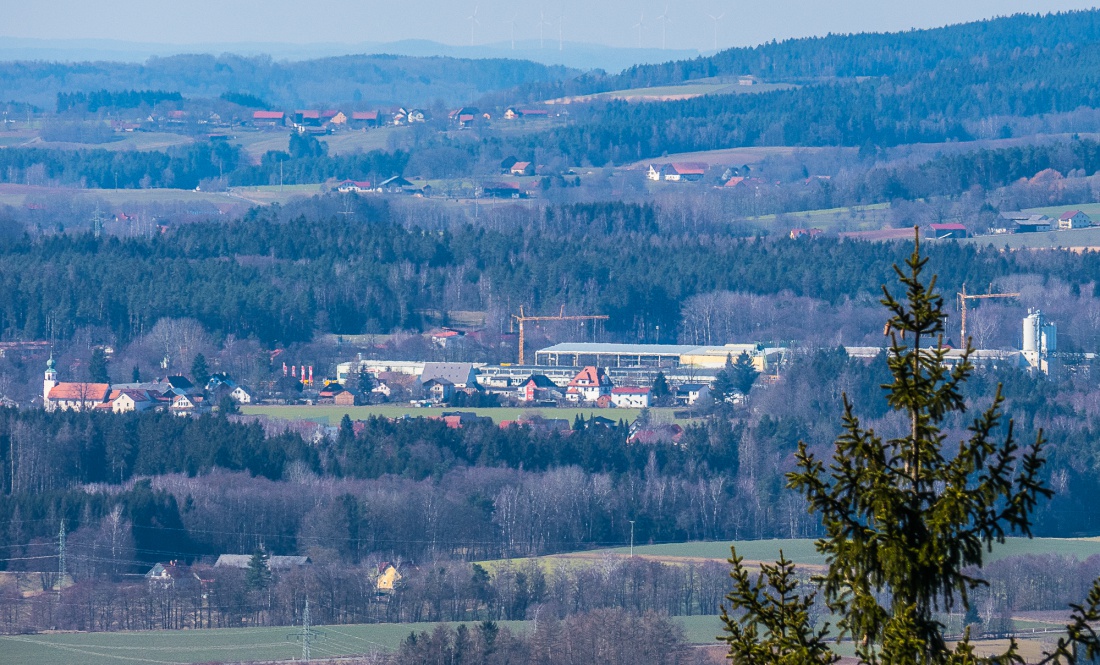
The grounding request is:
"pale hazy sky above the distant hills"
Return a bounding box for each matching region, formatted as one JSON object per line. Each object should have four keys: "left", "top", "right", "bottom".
{"left": 0, "top": 0, "right": 1097, "bottom": 51}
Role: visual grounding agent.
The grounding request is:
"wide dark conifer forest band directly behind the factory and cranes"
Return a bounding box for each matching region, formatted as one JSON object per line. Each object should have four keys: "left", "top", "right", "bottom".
{"left": 0, "top": 202, "right": 1100, "bottom": 345}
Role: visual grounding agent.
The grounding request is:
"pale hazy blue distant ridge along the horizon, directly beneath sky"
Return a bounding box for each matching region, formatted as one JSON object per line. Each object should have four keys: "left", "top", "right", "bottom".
{"left": 0, "top": 36, "right": 700, "bottom": 73}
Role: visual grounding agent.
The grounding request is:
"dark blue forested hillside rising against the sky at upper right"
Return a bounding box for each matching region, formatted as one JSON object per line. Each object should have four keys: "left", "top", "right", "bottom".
{"left": 495, "top": 11, "right": 1100, "bottom": 166}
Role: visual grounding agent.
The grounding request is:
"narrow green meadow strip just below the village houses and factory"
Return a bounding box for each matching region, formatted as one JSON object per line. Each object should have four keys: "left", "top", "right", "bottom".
{"left": 241, "top": 404, "right": 673, "bottom": 425}
